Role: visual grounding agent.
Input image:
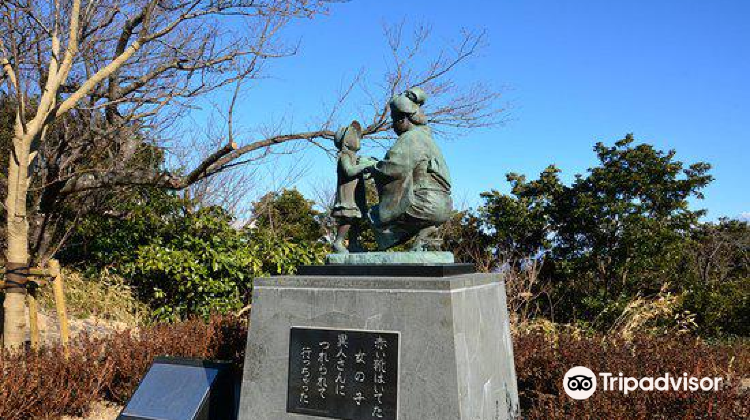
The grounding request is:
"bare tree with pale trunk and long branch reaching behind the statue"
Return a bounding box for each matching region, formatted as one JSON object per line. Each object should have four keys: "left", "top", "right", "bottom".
{"left": 0, "top": 0, "right": 500, "bottom": 348}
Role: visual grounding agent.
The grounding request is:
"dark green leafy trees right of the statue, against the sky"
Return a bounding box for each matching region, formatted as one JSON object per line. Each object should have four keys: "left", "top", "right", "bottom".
{"left": 472, "top": 135, "right": 750, "bottom": 338}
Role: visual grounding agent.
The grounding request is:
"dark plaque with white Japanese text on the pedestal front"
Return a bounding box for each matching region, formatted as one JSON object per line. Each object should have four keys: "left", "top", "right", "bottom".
{"left": 286, "top": 327, "right": 399, "bottom": 420}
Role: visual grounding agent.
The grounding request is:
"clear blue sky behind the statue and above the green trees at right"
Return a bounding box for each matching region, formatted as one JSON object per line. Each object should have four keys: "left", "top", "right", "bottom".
{"left": 201, "top": 0, "right": 750, "bottom": 219}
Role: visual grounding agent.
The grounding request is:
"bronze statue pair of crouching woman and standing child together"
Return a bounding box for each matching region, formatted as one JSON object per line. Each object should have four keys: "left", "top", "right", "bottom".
{"left": 333, "top": 87, "right": 453, "bottom": 252}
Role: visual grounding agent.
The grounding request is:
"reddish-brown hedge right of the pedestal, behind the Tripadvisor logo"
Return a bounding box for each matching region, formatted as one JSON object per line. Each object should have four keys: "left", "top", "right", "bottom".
{"left": 513, "top": 330, "right": 750, "bottom": 420}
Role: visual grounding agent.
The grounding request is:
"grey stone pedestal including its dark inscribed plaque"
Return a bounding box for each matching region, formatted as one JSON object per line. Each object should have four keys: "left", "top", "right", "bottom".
{"left": 239, "top": 265, "right": 518, "bottom": 420}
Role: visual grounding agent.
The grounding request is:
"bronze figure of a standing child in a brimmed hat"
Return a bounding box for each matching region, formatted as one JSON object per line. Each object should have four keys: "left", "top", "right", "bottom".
{"left": 331, "top": 121, "right": 377, "bottom": 254}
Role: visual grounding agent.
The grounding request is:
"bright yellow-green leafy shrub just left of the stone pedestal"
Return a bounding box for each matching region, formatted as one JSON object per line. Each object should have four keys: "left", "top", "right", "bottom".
{"left": 126, "top": 215, "right": 325, "bottom": 319}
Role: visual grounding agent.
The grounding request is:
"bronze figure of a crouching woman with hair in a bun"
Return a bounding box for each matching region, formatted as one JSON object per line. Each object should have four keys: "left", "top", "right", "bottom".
{"left": 369, "top": 87, "right": 453, "bottom": 251}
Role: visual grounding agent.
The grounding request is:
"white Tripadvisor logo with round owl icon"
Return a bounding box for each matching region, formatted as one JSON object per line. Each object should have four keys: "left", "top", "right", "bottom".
{"left": 563, "top": 366, "right": 723, "bottom": 400}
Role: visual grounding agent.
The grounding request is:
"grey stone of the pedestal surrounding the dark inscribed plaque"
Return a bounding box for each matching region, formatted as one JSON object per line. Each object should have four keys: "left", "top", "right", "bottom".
{"left": 239, "top": 274, "right": 518, "bottom": 420}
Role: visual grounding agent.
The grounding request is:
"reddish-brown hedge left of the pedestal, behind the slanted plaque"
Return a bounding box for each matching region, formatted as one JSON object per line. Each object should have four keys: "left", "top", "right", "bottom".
{"left": 0, "top": 316, "right": 247, "bottom": 420}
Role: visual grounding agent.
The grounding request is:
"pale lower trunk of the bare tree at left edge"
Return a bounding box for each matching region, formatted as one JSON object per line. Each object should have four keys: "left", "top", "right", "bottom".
{"left": 3, "top": 131, "right": 31, "bottom": 350}
